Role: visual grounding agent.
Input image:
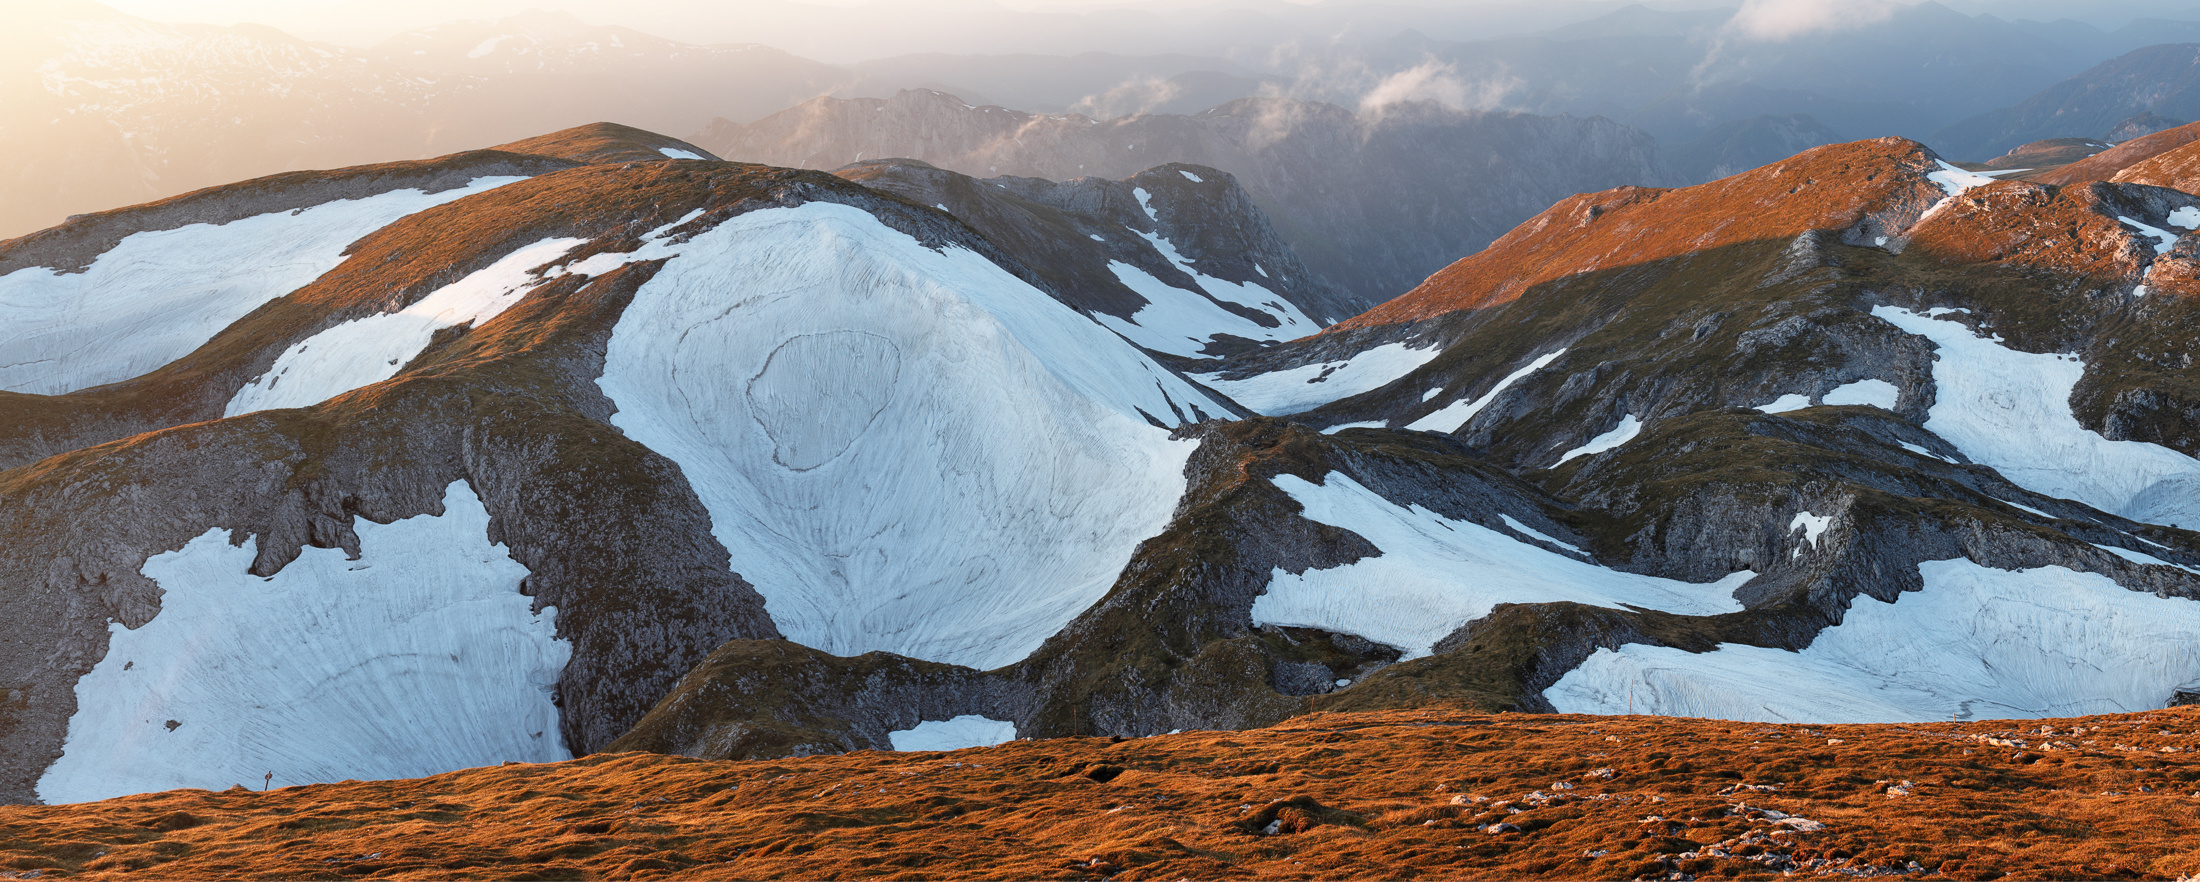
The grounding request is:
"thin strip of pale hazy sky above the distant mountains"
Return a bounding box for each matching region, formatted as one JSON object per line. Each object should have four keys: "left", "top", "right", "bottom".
{"left": 103, "top": 0, "right": 2200, "bottom": 64}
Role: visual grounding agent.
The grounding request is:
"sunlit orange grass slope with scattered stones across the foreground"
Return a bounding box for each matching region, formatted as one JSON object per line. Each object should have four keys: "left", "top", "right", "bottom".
{"left": 0, "top": 708, "right": 2200, "bottom": 880}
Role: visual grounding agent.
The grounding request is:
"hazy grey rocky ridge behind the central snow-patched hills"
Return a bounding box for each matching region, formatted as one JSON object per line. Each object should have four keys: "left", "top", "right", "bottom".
{"left": 693, "top": 90, "right": 1670, "bottom": 306}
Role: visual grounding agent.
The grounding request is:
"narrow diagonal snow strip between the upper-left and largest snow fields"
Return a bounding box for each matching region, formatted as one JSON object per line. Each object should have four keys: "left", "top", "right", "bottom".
{"left": 222, "top": 238, "right": 585, "bottom": 416}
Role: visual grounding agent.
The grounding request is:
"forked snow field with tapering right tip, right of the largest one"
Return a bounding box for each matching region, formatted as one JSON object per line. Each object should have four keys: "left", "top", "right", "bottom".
{"left": 1252, "top": 473, "right": 1756, "bottom": 658}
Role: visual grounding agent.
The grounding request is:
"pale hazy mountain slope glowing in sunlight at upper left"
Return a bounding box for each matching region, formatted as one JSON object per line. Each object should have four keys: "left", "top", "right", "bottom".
{"left": 0, "top": 2, "right": 862, "bottom": 235}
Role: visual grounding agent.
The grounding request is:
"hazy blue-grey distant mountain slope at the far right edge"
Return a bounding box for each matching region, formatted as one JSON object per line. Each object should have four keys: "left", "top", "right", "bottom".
{"left": 1927, "top": 44, "right": 2200, "bottom": 156}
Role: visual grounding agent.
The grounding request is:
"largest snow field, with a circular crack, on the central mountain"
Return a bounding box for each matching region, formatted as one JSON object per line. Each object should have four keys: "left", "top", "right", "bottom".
{"left": 602, "top": 202, "right": 1223, "bottom": 669}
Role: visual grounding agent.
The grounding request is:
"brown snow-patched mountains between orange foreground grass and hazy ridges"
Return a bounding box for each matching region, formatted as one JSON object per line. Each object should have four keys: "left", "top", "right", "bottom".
{"left": 0, "top": 116, "right": 2200, "bottom": 818}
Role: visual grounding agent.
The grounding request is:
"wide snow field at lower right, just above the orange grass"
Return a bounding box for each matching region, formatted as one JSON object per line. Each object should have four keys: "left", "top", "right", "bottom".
{"left": 1542, "top": 559, "right": 2200, "bottom": 724}
